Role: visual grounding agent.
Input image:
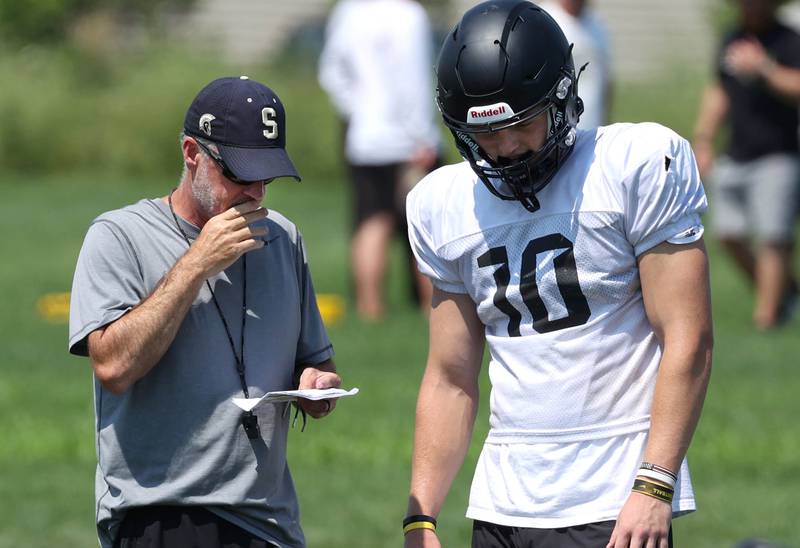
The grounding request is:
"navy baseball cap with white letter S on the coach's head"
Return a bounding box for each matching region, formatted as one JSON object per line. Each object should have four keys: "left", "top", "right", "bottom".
{"left": 183, "top": 76, "right": 300, "bottom": 181}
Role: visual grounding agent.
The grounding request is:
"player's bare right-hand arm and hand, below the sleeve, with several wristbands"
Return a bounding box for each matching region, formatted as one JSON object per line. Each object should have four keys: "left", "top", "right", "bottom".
{"left": 609, "top": 240, "right": 713, "bottom": 548}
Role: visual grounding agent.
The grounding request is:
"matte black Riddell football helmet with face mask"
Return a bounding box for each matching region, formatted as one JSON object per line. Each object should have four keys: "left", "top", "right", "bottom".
{"left": 436, "top": 0, "right": 583, "bottom": 212}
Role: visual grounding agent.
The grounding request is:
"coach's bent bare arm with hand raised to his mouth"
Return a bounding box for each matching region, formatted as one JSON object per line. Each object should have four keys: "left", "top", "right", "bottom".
{"left": 88, "top": 201, "right": 266, "bottom": 394}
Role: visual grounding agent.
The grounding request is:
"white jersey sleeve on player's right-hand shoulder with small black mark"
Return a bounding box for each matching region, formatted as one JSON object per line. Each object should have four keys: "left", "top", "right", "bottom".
{"left": 625, "top": 124, "right": 708, "bottom": 256}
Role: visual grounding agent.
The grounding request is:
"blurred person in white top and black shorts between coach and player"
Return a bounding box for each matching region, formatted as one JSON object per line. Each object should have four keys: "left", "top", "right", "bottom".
{"left": 319, "top": 0, "right": 440, "bottom": 320}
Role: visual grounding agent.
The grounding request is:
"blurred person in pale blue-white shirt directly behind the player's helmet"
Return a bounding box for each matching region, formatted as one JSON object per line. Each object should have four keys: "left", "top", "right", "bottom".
{"left": 541, "top": 0, "right": 612, "bottom": 129}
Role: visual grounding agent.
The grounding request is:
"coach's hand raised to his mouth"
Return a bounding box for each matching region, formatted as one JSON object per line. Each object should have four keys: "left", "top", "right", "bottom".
{"left": 187, "top": 200, "right": 267, "bottom": 278}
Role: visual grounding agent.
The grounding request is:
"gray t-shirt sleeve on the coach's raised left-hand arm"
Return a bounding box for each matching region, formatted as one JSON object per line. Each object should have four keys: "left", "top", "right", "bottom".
{"left": 69, "top": 218, "right": 147, "bottom": 356}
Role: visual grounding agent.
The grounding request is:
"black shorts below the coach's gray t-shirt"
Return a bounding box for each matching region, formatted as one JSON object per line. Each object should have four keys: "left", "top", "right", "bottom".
{"left": 114, "top": 506, "right": 275, "bottom": 548}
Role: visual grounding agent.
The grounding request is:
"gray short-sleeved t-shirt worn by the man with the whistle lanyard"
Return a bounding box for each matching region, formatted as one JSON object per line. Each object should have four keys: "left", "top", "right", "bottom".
{"left": 69, "top": 199, "right": 333, "bottom": 548}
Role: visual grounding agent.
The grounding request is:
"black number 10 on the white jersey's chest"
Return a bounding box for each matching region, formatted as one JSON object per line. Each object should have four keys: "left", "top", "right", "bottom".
{"left": 478, "top": 234, "right": 591, "bottom": 337}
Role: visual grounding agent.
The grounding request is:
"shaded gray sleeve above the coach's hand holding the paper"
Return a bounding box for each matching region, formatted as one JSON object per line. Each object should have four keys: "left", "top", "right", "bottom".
{"left": 295, "top": 232, "right": 333, "bottom": 365}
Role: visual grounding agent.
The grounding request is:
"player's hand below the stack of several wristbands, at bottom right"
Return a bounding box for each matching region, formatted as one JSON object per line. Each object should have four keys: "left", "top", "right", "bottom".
{"left": 606, "top": 493, "right": 672, "bottom": 548}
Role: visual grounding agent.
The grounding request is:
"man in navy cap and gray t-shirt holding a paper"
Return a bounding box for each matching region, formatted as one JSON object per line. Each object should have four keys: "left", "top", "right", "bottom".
{"left": 69, "top": 77, "right": 341, "bottom": 548}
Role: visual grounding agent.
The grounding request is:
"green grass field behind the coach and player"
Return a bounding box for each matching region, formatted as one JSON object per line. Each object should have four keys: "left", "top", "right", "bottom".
{"left": 0, "top": 70, "right": 800, "bottom": 548}
